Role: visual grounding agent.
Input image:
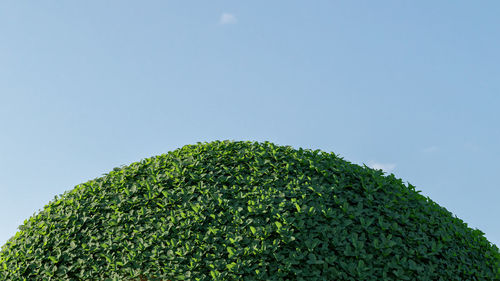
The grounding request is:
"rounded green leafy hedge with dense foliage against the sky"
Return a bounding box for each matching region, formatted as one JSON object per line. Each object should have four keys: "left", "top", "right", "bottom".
{"left": 0, "top": 141, "right": 500, "bottom": 281}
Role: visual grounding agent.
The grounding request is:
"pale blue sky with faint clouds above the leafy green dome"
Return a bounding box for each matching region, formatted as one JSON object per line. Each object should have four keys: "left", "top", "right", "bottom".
{"left": 0, "top": 0, "right": 500, "bottom": 247}
